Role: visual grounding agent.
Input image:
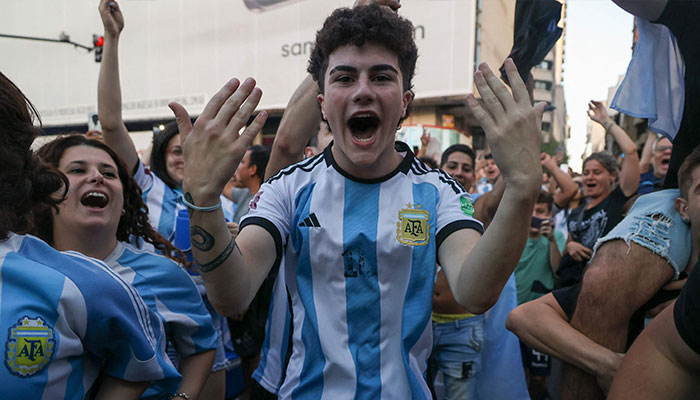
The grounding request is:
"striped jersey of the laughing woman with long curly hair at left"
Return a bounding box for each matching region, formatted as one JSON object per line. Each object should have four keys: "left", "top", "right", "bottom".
{"left": 104, "top": 242, "right": 218, "bottom": 399}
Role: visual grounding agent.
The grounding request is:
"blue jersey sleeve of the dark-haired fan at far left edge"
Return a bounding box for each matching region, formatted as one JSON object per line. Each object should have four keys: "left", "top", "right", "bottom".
{"left": 77, "top": 261, "right": 180, "bottom": 389}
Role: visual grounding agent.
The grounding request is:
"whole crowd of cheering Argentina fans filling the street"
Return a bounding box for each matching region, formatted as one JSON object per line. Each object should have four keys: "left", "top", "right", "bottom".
{"left": 0, "top": 0, "right": 700, "bottom": 400}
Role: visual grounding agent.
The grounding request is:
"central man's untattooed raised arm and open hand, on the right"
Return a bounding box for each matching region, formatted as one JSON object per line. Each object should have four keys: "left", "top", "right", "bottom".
{"left": 438, "top": 59, "right": 544, "bottom": 313}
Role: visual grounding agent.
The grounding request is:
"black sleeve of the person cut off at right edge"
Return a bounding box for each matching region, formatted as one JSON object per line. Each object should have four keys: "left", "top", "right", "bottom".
{"left": 673, "top": 264, "right": 700, "bottom": 354}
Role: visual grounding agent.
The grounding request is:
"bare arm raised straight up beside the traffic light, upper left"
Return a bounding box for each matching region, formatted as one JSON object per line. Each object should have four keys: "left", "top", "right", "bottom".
{"left": 97, "top": 0, "right": 138, "bottom": 168}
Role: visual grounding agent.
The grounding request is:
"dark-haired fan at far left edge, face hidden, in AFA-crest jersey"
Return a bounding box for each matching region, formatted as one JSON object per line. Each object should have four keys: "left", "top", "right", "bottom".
{"left": 0, "top": 73, "right": 179, "bottom": 399}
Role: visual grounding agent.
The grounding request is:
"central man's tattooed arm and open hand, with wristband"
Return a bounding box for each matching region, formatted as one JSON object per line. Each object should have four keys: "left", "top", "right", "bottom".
{"left": 169, "top": 78, "right": 276, "bottom": 315}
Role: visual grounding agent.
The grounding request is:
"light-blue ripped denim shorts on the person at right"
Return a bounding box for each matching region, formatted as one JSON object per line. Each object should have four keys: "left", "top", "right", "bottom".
{"left": 593, "top": 189, "right": 691, "bottom": 279}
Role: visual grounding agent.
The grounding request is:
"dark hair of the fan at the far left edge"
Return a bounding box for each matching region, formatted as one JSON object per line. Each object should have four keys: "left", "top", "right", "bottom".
{"left": 0, "top": 72, "right": 68, "bottom": 241}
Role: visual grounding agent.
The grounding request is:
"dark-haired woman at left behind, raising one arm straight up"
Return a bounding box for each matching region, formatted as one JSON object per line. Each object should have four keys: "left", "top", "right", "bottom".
{"left": 97, "top": 0, "right": 232, "bottom": 399}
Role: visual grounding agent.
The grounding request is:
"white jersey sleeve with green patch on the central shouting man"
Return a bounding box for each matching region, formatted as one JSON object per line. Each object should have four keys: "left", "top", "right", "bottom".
{"left": 436, "top": 174, "right": 484, "bottom": 247}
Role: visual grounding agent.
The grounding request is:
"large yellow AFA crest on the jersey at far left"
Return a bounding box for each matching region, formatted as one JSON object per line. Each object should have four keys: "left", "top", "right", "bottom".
{"left": 5, "top": 316, "right": 56, "bottom": 378}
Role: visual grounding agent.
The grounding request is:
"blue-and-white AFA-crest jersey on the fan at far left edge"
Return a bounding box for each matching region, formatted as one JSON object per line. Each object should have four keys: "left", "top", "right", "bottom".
{"left": 0, "top": 235, "right": 180, "bottom": 399}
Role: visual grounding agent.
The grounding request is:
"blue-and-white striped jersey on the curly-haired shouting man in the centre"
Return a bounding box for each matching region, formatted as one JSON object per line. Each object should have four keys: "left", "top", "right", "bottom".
{"left": 241, "top": 142, "right": 483, "bottom": 400}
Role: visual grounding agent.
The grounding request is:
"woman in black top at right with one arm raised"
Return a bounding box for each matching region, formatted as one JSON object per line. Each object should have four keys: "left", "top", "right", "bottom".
{"left": 557, "top": 101, "right": 639, "bottom": 286}
